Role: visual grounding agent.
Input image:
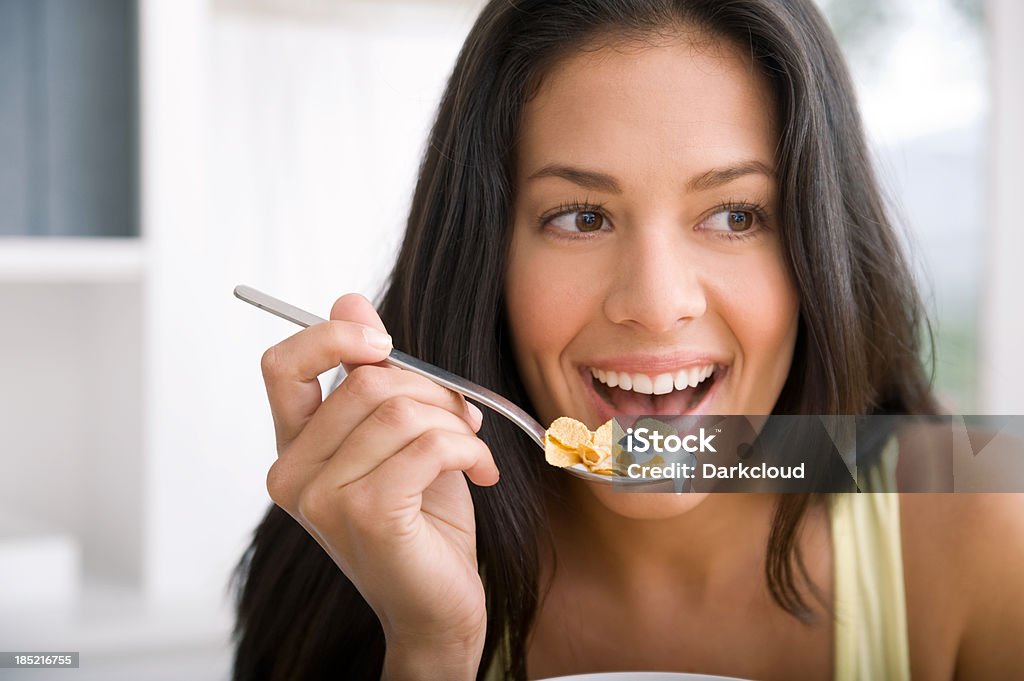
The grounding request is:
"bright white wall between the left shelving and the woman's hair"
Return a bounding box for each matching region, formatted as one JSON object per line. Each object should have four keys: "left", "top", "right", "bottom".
{"left": 142, "top": 0, "right": 483, "bottom": 601}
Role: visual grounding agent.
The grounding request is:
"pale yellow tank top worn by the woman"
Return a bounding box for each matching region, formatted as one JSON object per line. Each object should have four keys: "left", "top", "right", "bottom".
{"left": 485, "top": 441, "right": 910, "bottom": 681}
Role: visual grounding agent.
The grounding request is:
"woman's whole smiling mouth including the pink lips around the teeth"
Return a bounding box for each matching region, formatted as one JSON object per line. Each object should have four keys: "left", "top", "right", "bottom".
{"left": 581, "top": 359, "right": 728, "bottom": 422}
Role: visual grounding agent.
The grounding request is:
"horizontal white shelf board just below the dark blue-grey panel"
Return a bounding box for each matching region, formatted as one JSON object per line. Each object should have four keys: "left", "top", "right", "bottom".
{"left": 0, "top": 237, "right": 143, "bottom": 283}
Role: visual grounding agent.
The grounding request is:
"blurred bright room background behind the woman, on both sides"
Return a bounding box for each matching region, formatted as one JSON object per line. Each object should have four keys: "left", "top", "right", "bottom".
{"left": 0, "top": 0, "right": 1024, "bottom": 680}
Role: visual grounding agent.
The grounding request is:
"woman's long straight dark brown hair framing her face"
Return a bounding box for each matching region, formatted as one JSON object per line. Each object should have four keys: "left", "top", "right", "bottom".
{"left": 234, "top": 0, "right": 936, "bottom": 681}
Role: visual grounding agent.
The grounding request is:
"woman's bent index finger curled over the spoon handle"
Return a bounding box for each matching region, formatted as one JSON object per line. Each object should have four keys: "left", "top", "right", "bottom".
{"left": 261, "top": 321, "right": 391, "bottom": 451}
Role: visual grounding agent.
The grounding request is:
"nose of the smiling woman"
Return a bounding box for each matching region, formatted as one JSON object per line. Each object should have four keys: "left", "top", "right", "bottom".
{"left": 604, "top": 225, "right": 708, "bottom": 335}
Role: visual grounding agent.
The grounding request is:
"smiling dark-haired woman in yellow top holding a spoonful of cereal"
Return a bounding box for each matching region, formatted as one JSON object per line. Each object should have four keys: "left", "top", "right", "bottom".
{"left": 234, "top": 0, "right": 1024, "bottom": 680}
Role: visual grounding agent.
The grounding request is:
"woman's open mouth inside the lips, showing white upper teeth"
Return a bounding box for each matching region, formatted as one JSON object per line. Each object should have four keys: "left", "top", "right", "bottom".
{"left": 589, "top": 364, "right": 726, "bottom": 416}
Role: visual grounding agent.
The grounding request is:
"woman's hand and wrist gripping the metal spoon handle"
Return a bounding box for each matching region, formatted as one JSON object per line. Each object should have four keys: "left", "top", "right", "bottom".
{"left": 262, "top": 295, "right": 498, "bottom": 679}
